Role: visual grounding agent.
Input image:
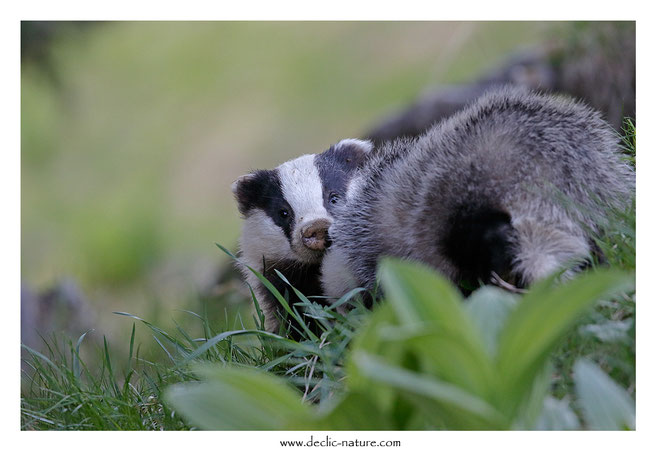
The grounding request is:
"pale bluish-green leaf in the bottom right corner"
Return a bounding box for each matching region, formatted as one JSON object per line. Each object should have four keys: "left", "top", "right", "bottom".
{"left": 573, "top": 359, "right": 636, "bottom": 430}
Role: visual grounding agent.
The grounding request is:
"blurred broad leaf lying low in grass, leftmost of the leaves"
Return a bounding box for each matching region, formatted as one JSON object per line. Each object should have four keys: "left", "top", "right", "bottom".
{"left": 165, "top": 365, "right": 314, "bottom": 430}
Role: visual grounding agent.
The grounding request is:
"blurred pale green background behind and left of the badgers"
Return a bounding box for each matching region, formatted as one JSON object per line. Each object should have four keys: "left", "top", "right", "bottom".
{"left": 21, "top": 22, "right": 563, "bottom": 342}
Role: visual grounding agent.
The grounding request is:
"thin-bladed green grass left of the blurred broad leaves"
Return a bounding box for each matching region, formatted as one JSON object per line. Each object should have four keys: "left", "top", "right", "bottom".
{"left": 22, "top": 276, "right": 366, "bottom": 430}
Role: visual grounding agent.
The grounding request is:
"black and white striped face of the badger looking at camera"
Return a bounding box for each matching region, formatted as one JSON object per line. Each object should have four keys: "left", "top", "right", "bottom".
{"left": 232, "top": 140, "right": 372, "bottom": 264}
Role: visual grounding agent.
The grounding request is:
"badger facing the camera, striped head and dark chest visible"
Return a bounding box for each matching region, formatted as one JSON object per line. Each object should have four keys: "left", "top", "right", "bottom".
{"left": 232, "top": 139, "right": 372, "bottom": 331}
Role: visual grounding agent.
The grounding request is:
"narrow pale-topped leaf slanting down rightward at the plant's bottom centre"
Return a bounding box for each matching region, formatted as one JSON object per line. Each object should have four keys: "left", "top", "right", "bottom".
{"left": 354, "top": 352, "right": 508, "bottom": 429}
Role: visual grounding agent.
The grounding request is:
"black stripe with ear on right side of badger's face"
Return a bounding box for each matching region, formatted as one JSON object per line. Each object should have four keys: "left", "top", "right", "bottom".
{"left": 314, "top": 143, "right": 367, "bottom": 213}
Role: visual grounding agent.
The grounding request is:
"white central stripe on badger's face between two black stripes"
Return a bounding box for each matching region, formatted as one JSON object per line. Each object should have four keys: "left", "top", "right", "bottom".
{"left": 278, "top": 155, "right": 330, "bottom": 226}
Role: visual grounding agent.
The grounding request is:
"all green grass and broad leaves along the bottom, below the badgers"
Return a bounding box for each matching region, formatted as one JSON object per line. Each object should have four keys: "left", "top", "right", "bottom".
{"left": 21, "top": 252, "right": 634, "bottom": 430}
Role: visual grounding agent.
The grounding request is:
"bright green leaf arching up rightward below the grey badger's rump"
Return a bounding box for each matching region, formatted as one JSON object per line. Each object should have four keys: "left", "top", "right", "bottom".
{"left": 497, "top": 270, "right": 632, "bottom": 414}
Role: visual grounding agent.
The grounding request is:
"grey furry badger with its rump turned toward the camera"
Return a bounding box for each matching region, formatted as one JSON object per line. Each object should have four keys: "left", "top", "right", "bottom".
{"left": 321, "top": 87, "right": 634, "bottom": 297}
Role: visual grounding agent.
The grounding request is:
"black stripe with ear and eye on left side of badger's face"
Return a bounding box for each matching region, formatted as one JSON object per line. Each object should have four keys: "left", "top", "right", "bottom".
{"left": 235, "top": 169, "right": 294, "bottom": 242}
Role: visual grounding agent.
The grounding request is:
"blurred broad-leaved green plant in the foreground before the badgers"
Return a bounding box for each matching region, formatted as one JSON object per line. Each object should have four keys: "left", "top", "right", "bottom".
{"left": 161, "top": 260, "right": 632, "bottom": 430}
